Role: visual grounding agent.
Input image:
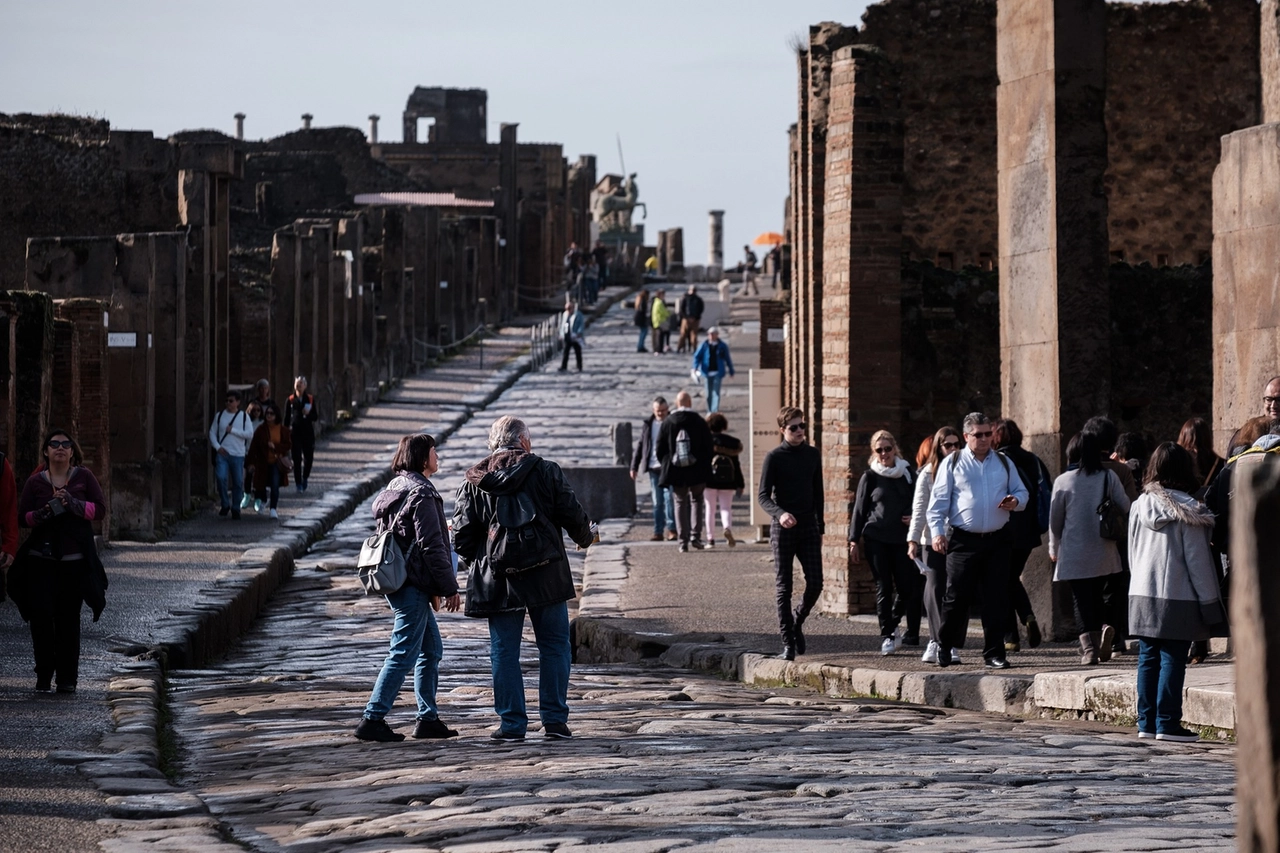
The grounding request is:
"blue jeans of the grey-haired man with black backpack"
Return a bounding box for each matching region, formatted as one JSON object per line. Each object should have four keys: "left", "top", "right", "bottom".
{"left": 489, "top": 602, "right": 573, "bottom": 734}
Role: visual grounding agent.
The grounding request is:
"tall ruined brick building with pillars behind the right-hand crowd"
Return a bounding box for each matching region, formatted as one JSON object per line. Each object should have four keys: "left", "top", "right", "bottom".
{"left": 765, "top": 0, "right": 1262, "bottom": 627}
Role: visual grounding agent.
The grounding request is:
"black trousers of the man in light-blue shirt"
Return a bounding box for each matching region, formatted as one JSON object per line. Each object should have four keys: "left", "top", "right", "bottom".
{"left": 941, "top": 526, "right": 1011, "bottom": 661}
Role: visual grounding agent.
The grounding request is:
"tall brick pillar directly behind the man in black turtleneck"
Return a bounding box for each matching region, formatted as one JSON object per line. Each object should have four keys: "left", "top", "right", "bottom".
{"left": 814, "top": 46, "right": 902, "bottom": 613}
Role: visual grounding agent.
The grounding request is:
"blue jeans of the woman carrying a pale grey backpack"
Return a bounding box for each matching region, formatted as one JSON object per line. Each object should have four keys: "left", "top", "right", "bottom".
{"left": 365, "top": 584, "right": 444, "bottom": 720}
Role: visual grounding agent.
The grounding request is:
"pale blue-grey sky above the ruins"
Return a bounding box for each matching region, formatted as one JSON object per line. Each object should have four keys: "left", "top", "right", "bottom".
{"left": 0, "top": 0, "right": 867, "bottom": 264}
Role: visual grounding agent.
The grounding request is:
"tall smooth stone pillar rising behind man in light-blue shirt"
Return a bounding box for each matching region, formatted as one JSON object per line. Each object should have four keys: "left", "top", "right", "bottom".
{"left": 988, "top": 0, "right": 1111, "bottom": 639}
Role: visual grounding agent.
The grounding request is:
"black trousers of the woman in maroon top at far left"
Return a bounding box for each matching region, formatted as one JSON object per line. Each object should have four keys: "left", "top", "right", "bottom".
{"left": 31, "top": 560, "right": 88, "bottom": 686}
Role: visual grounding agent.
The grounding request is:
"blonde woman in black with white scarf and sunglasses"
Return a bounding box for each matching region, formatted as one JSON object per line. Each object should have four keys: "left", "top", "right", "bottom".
{"left": 849, "top": 429, "right": 924, "bottom": 654}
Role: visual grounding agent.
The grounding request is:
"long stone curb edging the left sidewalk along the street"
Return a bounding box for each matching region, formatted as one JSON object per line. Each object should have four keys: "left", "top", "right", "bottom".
{"left": 77, "top": 281, "right": 634, "bottom": 820}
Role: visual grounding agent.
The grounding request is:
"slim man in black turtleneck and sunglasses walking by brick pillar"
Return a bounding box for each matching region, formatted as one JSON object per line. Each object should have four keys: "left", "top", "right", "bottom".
{"left": 756, "top": 406, "right": 823, "bottom": 661}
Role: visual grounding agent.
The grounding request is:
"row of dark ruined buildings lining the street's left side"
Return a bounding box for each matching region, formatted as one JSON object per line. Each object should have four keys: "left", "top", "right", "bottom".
{"left": 0, "top": 88, "right": 595, "bottom": 537}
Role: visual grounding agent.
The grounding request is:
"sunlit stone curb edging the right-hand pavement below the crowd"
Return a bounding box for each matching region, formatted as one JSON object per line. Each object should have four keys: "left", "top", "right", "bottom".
{"left": 573, "top": 522, "right": 1235, "bottom": 738}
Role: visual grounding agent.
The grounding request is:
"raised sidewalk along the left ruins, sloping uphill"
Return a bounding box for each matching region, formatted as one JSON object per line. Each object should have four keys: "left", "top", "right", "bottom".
{"left": 0, "top": 288, "right": 625, "bottom": 850}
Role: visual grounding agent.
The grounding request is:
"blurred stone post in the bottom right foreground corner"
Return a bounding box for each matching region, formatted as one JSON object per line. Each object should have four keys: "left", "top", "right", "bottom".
{"left": 1230, "top": 458, "right": 1280, "bottom": 853}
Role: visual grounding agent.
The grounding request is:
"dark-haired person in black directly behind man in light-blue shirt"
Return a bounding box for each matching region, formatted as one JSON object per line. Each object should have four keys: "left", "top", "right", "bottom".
{"left": 992, "top": 418, "right": 1053, "bottom": 652}
